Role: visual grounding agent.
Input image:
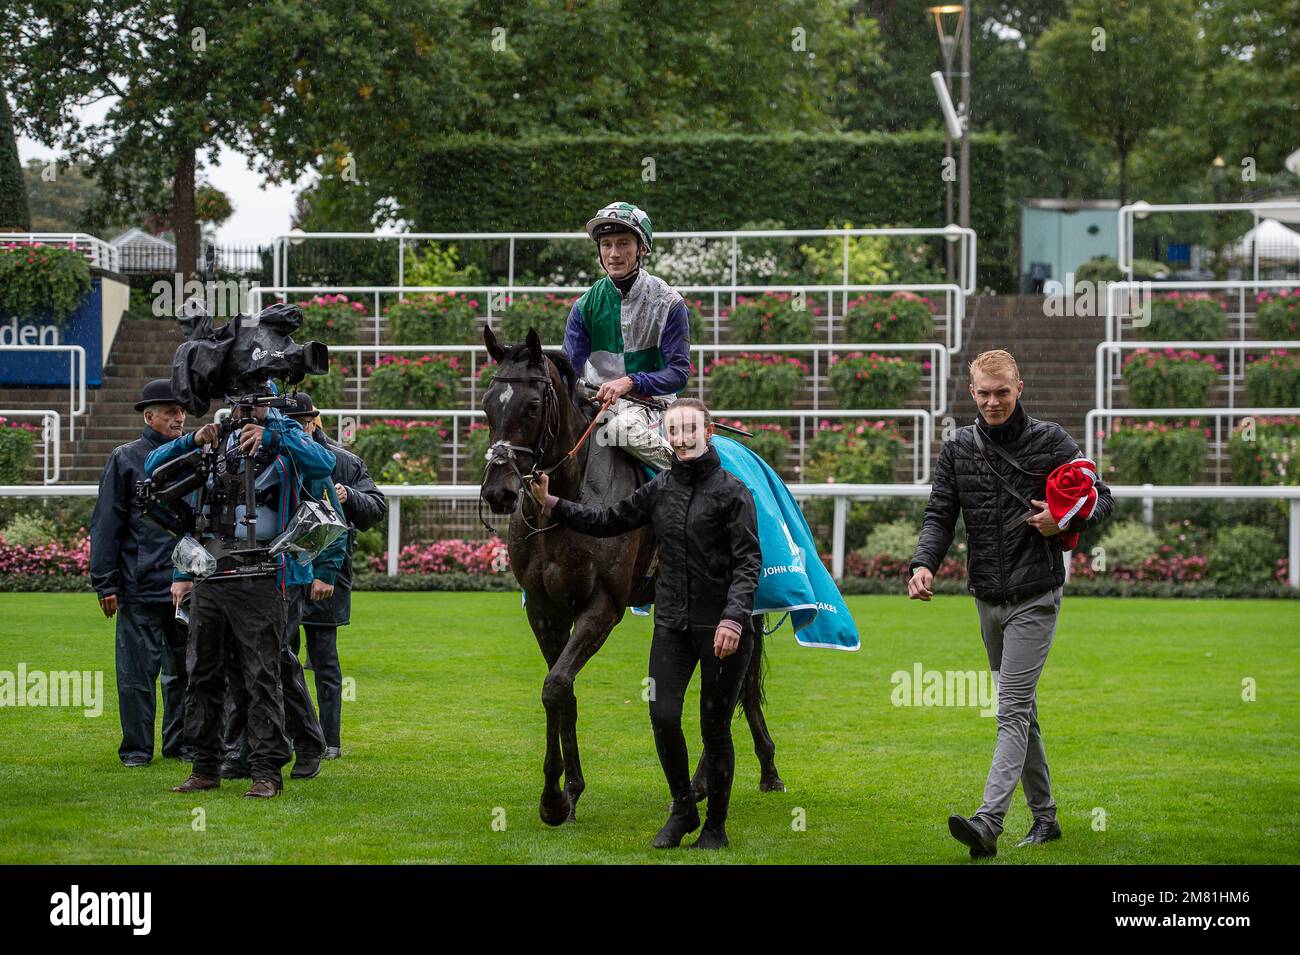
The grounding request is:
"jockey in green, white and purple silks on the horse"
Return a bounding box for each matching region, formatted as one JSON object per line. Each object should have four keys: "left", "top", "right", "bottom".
{"left": 564, "top": 203, "right": 690, "bottom": 470}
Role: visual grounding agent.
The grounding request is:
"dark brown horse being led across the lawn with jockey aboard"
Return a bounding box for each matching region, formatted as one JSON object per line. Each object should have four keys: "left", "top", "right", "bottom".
{"left": 481, "top": 329, "right": 785, "bottom": 825}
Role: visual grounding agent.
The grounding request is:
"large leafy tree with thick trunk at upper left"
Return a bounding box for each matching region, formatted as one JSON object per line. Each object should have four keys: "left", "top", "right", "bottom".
{"left": 9, "top": 0, "right": 460, "bottom": 275}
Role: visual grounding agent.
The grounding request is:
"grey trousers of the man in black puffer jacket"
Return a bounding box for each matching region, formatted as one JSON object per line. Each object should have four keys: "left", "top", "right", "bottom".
{"left": 975, "top": 587, "right": 1061, "bottom": 834}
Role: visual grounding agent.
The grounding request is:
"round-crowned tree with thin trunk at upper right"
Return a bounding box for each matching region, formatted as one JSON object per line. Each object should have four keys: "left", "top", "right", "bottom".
{"left": 1030, "top": 0, "right": 1201, "bottom": 203}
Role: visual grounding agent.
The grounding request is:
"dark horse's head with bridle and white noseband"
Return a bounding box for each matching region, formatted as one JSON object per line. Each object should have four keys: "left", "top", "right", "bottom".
{"left": 482, "top": 327, "right": 568, "bottom": 515}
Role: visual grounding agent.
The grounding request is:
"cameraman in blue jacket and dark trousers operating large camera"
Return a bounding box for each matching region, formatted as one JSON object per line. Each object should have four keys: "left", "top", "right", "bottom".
{"left": 144, "top": 394, "right": 334, "bottom": 798}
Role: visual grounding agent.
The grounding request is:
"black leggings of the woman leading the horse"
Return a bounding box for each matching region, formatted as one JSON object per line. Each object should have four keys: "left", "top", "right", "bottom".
{"left": 650, "top": 625, "right": 754, "bottom": 821}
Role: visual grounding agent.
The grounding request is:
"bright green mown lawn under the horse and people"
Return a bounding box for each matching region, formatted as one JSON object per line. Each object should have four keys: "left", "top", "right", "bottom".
{"left": 0, "top": 594, "right": 1300, "bottom": 865}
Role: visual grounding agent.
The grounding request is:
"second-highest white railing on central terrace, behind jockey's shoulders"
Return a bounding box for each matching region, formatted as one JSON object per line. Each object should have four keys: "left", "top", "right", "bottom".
{"left": 244, "top": 283, "right": 966, "bottom": 355}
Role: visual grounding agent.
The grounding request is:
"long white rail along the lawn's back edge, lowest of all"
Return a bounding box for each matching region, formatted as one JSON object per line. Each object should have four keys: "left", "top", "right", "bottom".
{"left": 0, "top": 485, "right": 1300, "bottom": 587}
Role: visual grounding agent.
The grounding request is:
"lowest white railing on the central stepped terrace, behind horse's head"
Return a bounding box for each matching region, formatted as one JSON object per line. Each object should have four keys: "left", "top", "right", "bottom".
{"left": 317, "top": 408, "right": 935, "bottom": 486}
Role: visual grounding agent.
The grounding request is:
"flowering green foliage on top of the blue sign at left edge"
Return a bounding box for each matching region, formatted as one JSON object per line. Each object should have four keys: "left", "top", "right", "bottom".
{"left": 0, "top": 242, "right": 91, "bottom": 326}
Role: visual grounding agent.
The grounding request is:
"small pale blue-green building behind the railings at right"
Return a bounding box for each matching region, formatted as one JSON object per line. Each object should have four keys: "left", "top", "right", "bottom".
{"left": 1021, "top": 199, "right": 1119, "bottom": 292}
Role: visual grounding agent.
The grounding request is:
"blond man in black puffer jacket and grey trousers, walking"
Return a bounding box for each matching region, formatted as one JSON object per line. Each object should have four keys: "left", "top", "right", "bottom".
{"left": 907, "top": 351, "right": 1114, "bottom": 856}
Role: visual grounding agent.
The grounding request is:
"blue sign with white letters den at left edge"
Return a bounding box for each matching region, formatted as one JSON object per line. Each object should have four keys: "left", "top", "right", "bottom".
{"left": 0, "top": 275, "right": 104, "bottom": 387}
